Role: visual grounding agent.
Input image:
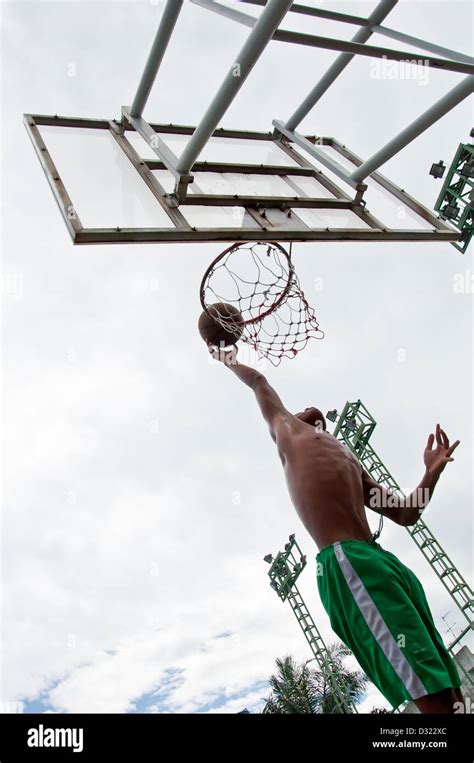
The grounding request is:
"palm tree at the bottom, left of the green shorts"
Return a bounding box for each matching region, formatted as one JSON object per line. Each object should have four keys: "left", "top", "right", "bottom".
{"left": 262, "top": 643, "right": 369, "bottom": 714}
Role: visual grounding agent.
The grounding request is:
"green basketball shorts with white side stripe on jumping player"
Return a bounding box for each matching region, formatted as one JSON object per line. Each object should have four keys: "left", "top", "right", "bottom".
{"left": 316, "top": 540, "right": 461, "bottom": 707}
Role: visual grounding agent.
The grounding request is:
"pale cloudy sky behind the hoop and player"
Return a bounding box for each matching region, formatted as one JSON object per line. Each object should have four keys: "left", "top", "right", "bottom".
{"left": 0, "top": 0, "right": 474, "bottom": 713}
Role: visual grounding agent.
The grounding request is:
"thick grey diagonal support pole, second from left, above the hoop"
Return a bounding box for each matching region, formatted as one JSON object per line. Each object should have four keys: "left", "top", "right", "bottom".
{"left": 176, "top": 0, "right": 292, "bottom": 175}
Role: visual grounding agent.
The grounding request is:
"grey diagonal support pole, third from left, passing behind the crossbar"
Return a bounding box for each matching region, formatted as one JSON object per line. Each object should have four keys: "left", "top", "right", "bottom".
{"left": 285, "top": 0, "right": 397, "bottom": 130}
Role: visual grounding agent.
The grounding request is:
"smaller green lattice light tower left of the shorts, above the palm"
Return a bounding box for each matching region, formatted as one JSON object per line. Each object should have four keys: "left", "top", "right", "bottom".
{"left": 265, "top": 535, "right": 357, "bottom": 713}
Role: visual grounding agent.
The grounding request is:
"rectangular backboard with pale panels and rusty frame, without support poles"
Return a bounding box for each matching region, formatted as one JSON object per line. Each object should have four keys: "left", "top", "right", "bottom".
{"left": 24, "top": 114, "right": 459, "bottom": 244}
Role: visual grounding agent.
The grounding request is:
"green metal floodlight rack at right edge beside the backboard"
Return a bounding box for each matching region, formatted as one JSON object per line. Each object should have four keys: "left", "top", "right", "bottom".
{"left": 434, "top": 143, "right": 474, "bottom": 253}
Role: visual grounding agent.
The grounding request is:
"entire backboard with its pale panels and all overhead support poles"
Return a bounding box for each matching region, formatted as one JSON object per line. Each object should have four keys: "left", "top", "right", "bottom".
{"left": 24, "top": 0, "right": 474, "bottom": 244}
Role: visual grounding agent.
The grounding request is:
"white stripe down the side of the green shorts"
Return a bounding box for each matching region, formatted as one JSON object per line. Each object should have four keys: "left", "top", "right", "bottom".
{"left": 334, "top": 543, "right": 428, "bottom": 699}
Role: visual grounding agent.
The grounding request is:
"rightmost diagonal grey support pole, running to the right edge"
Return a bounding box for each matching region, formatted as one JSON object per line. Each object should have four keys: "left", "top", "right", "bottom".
{"left": 352, "top": 75, "right": 474, "bottom": 183}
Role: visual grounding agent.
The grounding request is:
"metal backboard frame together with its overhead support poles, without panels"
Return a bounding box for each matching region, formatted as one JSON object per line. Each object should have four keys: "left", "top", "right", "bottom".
{"left": 24, "top": 0, "right": 474, "bottom": 244}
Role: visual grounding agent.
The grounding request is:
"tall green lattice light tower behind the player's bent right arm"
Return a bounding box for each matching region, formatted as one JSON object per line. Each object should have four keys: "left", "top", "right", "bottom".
{"left": 328, "top": 400, "right": 474, "bottom": 632}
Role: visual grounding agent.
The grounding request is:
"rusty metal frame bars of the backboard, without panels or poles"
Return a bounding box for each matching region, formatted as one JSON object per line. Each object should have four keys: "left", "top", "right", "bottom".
{"left": 25, "top": 114, "right": 459, "bottom": 244}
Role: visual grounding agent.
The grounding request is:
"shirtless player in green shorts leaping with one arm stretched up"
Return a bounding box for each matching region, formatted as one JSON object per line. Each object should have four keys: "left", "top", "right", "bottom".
{"left": 209, "top": 347, "right": 463, "bottom": 713}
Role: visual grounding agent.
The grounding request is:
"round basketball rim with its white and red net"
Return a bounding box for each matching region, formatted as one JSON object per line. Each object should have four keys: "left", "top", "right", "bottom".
{"left": 200, "top": 241, "right": 324, "bottom": 366}
